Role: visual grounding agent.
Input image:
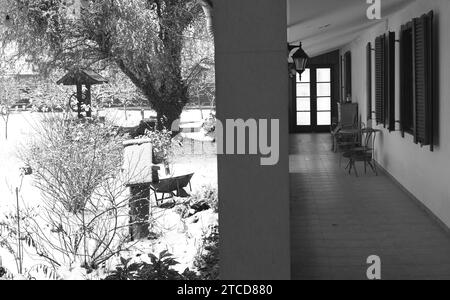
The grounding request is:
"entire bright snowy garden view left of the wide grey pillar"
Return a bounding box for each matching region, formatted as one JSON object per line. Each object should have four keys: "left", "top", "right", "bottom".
{"left": 0, "top": 0, "right": 219, "bottom": 280}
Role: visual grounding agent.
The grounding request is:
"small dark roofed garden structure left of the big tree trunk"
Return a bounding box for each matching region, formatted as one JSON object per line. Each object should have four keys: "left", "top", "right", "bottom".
{"left": 57, "top": 69, "right": 108, "bottom": 119}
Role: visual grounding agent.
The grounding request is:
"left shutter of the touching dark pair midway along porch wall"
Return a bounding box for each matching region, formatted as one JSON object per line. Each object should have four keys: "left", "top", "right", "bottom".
{"left": 375, "top": 35, "right": 386, "bottom": 124}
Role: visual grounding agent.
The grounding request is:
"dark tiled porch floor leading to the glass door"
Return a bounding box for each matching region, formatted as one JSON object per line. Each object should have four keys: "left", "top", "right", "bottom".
{"left": 290, "top": 134, "right": 450, "bottom": 280}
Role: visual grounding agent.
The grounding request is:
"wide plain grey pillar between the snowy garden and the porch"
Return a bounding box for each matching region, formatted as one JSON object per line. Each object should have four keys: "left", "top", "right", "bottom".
{"left": 214, "top": 0, "right": 290, "bottom": 280}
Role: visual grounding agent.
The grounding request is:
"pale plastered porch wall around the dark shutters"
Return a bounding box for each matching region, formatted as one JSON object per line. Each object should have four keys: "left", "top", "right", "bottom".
{"left": 341, "top": 0, "right": 450, "bottom": 227}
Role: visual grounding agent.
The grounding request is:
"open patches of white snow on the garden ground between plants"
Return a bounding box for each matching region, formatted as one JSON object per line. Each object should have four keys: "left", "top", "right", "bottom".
{"left": 0, "top": 109, "right": 218, "bottom": 279}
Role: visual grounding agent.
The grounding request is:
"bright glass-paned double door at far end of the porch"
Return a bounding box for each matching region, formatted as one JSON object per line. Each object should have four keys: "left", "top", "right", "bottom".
{"left": 295, "top": 68, "right": 332, "bottom": 132}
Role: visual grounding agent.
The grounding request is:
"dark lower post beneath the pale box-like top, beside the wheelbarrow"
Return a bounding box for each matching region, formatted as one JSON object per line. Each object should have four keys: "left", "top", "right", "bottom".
{"left": 130, "top": 184, "right": 150, "bottom": 241}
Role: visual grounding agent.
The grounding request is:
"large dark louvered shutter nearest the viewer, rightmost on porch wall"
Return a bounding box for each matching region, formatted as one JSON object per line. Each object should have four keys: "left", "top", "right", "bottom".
{"left": 413, "top": 12, "right": 434, "bottom": 150}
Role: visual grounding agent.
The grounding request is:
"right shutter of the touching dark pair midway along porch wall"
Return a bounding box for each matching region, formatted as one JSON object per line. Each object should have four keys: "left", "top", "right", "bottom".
{"left": 385, "top": 32, "right": 395, "bottom": 131}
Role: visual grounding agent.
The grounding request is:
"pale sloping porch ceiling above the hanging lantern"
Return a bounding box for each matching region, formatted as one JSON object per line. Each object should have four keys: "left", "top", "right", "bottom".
{"left": 287, "top": 0, "right": 411, "bottom": 56}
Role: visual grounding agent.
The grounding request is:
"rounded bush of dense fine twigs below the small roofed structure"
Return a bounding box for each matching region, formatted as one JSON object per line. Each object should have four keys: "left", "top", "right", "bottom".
{"left": 22, "top": 115, "right": 124, "bottom": 214}
